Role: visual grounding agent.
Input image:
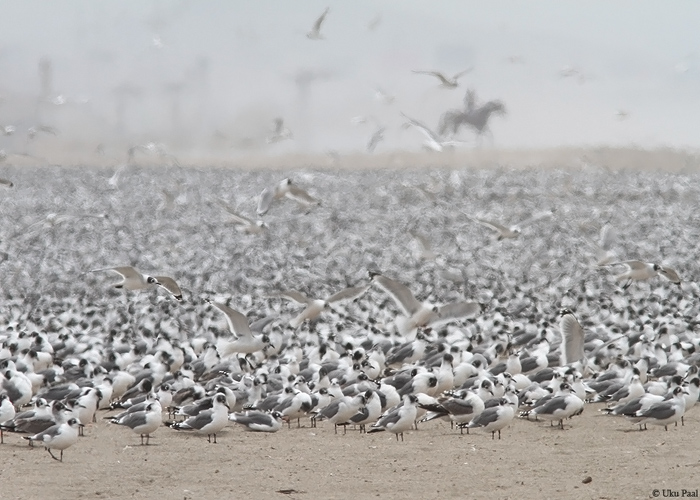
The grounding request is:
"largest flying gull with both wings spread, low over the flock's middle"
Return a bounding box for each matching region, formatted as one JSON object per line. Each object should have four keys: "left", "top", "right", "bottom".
{"left": 369, "top": 271, "right": 481, "bottom": 335}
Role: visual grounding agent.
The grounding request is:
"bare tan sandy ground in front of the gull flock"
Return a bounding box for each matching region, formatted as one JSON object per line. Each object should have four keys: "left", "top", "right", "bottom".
{"left": 0, "top": 404, "right": 700, "bottom": 500}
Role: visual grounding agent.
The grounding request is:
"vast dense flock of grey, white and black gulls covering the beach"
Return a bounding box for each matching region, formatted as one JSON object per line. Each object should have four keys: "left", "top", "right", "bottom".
{"left": 0, "top": 158, "right": 700, "bottom": 460}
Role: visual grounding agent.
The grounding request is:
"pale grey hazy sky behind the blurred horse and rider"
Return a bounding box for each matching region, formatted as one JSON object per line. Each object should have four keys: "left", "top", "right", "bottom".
{"left": 0, "top": 0, "right": 700, "bottom": 153}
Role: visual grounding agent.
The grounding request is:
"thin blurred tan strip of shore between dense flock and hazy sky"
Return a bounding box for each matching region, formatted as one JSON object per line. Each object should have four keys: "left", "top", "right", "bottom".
{"left": 0, "top": 147, "right": 700, "bottom": 172}
